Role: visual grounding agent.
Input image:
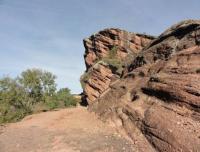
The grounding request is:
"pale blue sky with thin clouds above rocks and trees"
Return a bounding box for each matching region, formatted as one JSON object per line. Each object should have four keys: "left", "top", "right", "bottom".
{"left": 0, "top": 0, "right": 200, "bottom": 93}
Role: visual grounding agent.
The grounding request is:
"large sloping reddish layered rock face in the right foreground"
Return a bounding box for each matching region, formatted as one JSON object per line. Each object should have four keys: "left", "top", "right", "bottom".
{"left": 82, "top": 20, "right": 200, "bottom": 152}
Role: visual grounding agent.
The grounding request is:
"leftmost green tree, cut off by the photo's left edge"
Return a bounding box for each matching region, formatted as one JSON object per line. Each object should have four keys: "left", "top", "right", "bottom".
{"left": 0, "top": 77, "right": 30, "bottom": 123}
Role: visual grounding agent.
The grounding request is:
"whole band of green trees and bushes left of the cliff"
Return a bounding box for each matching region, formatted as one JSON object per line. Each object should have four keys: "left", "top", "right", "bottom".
{"left": 0, "top": 69, "right": 78, "bottom": 123}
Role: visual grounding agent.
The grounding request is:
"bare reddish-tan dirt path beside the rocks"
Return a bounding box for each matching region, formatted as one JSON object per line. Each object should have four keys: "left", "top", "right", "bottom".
{"left": 0, "top": 107, "right": 135, "bottom": 152}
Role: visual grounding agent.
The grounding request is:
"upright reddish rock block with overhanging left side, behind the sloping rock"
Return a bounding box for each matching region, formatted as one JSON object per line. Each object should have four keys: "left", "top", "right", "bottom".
{"left": 81, "top": 28, "right": 154, "bottom": 104}
